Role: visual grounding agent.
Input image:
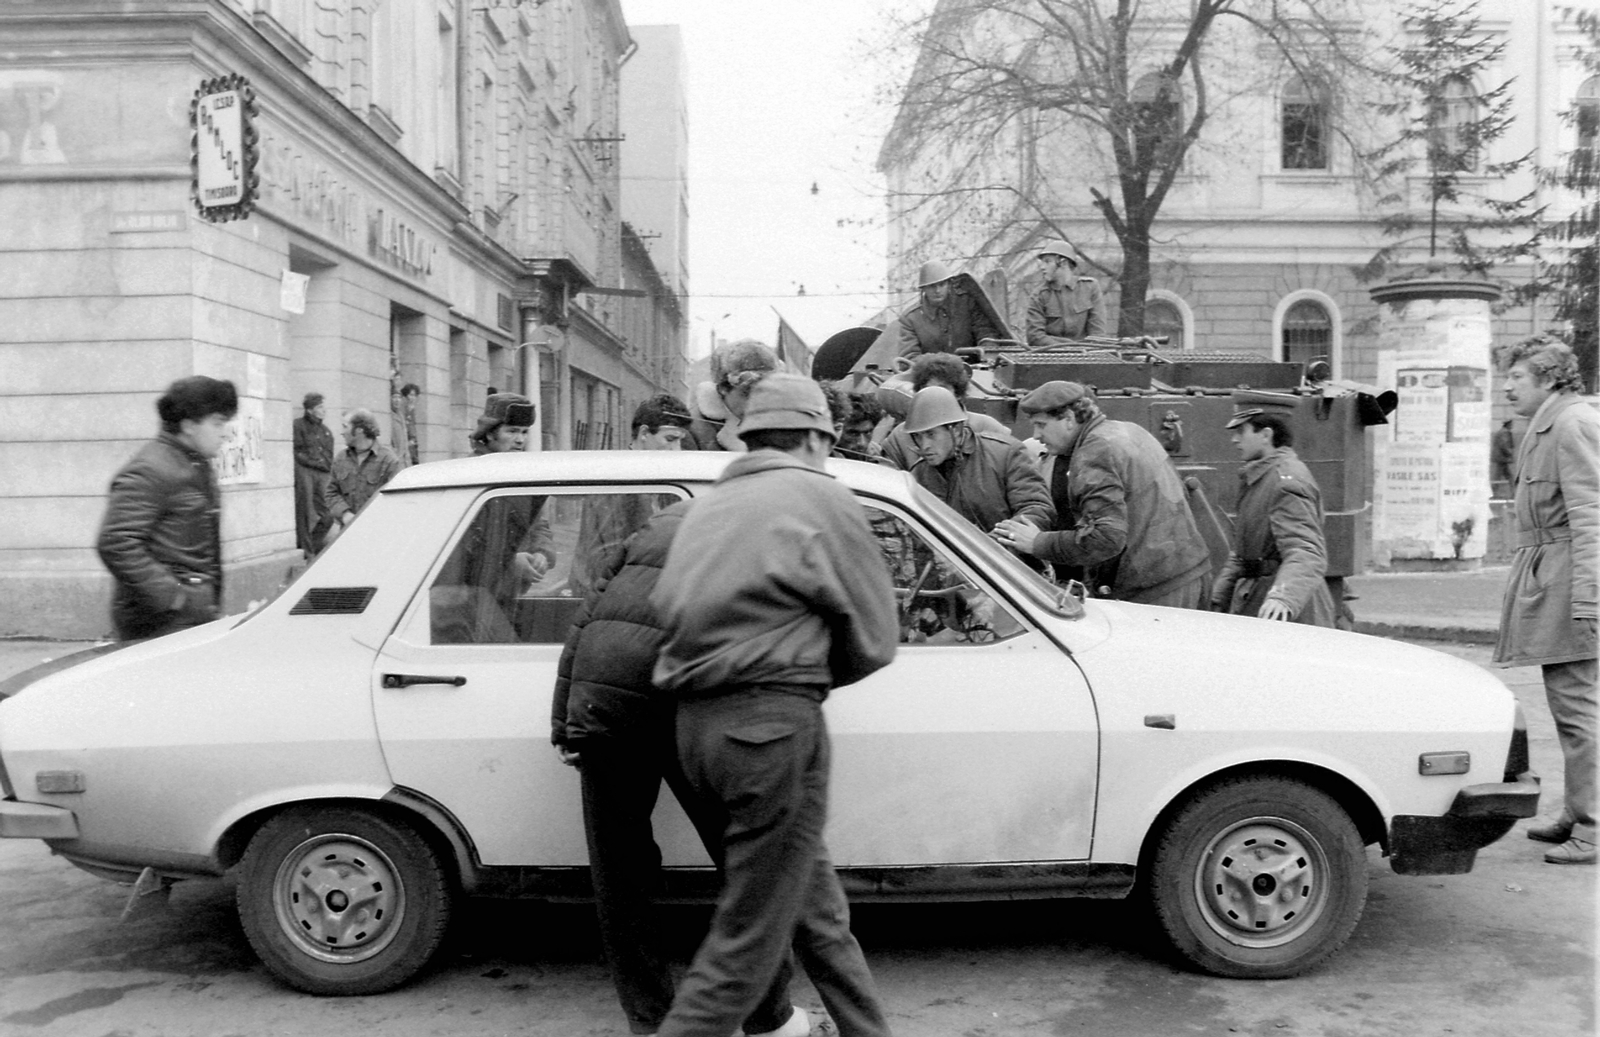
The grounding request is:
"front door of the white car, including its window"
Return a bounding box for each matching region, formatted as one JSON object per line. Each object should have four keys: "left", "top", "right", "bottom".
{"left": 826, "top": 501, "right": 1099, "bottom": 867}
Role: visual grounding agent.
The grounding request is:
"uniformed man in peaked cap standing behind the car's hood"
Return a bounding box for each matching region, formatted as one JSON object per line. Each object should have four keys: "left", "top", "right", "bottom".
{"left": 1211, "top": 392, "right": 1338, "bottom": 627}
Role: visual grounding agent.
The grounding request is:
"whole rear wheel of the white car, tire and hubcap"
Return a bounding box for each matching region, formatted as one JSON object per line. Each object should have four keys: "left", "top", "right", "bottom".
{"left": 237, "top": 807, "right": 451, "bottom": 995}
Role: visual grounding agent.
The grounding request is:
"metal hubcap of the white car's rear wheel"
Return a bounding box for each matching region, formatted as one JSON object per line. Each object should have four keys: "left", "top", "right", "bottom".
{"left": 274, "top": 835, "right": 405, "bottom": 963}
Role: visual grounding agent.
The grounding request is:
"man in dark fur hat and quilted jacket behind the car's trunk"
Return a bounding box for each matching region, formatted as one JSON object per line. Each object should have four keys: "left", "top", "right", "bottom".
{"left": 98, "top": 374, "right": 238, "bottom": 640}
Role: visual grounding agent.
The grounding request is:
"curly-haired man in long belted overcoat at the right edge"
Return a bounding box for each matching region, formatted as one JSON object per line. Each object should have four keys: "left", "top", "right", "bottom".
{"left": 1494, "top": 336, "right": 1600, "bottom": 864}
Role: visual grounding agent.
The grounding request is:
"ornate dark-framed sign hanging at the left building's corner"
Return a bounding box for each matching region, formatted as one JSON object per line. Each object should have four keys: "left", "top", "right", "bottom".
{"left": 189, "top": 75, "right": 261, "bottom": 222}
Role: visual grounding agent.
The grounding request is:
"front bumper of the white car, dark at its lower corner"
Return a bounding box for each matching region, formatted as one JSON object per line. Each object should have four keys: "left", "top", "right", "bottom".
{"left": 1389, "top": 771, "right": 1539, "bottom": 875}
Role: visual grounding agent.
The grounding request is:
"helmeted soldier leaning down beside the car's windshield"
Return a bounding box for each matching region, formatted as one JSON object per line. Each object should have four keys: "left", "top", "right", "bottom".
{"left": 906, "top": 386, "right": 1056, "bottom": 535}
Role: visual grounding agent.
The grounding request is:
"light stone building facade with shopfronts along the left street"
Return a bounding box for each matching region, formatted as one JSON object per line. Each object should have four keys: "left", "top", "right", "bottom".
{"left": 0, "top": 0, "right": 681, "bottom": 637}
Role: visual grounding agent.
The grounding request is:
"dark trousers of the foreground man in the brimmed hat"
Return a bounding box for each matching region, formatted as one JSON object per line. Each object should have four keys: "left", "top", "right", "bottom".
{"left": 661, "top": 685, "right": 890, "bottom": 1037}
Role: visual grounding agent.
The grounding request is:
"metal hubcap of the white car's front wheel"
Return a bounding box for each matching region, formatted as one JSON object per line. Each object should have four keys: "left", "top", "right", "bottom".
{"left": 1195, "top": 818, "right": 1330, "bottom": 947}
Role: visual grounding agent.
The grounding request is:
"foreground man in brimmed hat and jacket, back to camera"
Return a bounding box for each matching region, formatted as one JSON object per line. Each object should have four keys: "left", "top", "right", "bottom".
{"left": 651, "top": 374, "right": 899, "bottom": 1037}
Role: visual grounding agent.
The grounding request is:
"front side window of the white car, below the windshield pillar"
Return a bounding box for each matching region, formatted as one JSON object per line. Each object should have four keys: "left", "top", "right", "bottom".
{"left": 864, "top": 504, "right": 1022, "bottom": 645}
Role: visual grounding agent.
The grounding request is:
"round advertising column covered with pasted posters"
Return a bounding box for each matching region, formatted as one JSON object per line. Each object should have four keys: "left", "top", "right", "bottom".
{"left": 1371, "top": 278, "right": 1501, "bottom": 568}
